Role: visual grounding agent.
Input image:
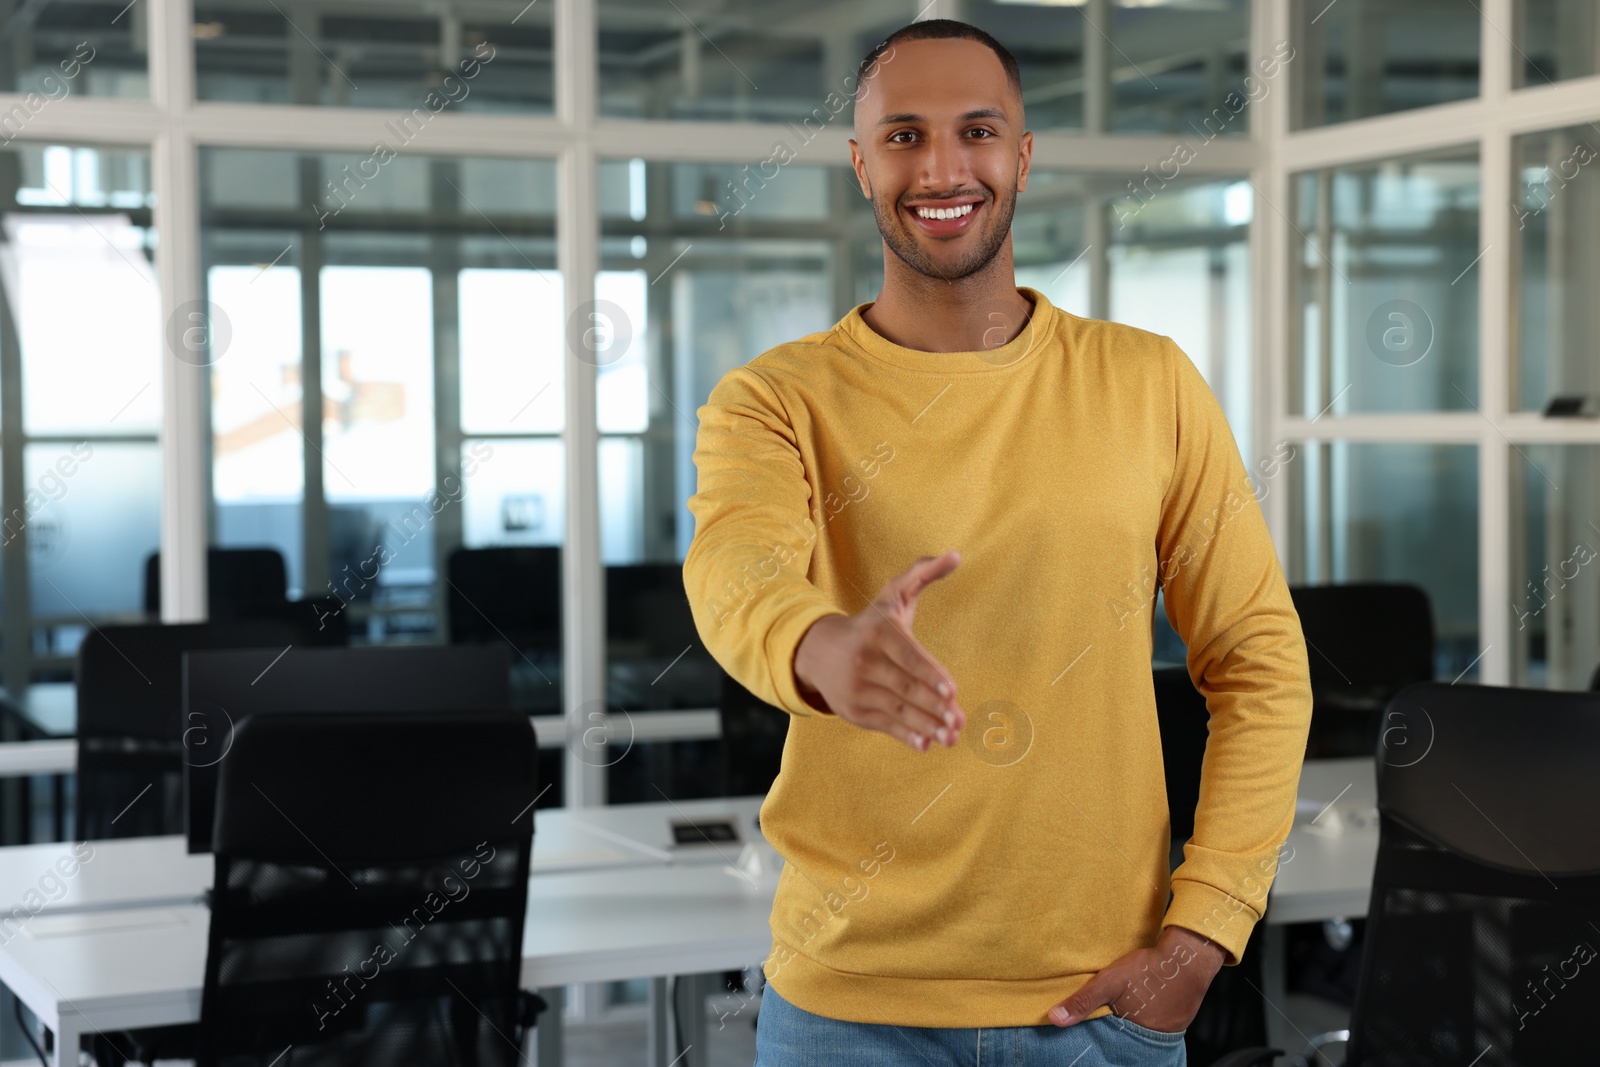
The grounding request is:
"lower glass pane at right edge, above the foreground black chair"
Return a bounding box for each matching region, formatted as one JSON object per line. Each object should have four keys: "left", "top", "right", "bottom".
{"left": 1506, "top": 445, "right": 1600, "bottom": 689}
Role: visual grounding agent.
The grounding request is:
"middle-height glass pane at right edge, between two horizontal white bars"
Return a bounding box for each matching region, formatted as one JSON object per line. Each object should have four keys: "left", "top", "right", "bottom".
{"left": 1512, "top": 125, "right": 1600, "bottom": 411}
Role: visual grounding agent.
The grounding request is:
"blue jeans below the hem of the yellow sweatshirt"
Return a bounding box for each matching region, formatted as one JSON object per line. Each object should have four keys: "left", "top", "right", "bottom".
{"left": 755, "top": 985, "right": 1189, "bottom": 1067}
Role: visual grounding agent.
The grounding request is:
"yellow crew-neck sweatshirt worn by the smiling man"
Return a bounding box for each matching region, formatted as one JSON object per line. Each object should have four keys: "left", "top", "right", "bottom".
{"left": 683, "top": 288, "right": 1310, "bottom": 1027}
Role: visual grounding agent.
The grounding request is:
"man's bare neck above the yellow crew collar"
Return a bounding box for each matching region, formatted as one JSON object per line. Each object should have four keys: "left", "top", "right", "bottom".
{"left": 862, "top": 250, "right": 1034, "bottom": 352}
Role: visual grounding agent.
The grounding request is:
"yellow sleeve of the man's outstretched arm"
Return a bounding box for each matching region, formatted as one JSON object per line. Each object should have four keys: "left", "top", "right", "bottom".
{"left": 683, "top": 366, "right": 843, "bottom": 715}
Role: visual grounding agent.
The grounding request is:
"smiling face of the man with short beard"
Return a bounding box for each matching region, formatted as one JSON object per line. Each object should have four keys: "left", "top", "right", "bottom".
{"left": 850, "top": 40, "right": 1034, "bottom": 282}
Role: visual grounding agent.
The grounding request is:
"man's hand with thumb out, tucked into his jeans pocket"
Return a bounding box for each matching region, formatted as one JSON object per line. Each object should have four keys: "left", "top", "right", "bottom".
{"left": 1050, "top": 926, "right": 1227, "bottom": 1033}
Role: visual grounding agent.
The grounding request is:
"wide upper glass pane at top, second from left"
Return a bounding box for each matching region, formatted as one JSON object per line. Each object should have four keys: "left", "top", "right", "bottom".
{"left": 194, "top": 0, "right": 555, "bottom": 110}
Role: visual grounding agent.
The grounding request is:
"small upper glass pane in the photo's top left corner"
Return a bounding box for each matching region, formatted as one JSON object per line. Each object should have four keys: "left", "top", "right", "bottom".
{"left": 0, "top": 0, "right": 150, "bottom": 99}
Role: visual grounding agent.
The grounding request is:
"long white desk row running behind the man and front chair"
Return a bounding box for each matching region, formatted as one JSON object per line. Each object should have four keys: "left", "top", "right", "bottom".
{"left": 0, "top": 760, "right": 1378, "bottom": 1067}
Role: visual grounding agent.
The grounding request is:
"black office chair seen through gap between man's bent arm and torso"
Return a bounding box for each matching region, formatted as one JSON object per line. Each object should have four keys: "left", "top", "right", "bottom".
{"left": 1152, "top": 667, "right": 1267, "bottom": 1064}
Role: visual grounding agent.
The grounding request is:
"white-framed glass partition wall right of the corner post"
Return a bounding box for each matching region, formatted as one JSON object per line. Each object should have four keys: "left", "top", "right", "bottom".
{"left": 1273, "top": 0, "right": 1600, "bottom": 689}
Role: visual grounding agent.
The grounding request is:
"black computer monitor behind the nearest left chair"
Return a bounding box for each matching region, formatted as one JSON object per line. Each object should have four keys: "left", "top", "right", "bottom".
{"left": 182, "top": 645, "right": 510, "bottom": 853}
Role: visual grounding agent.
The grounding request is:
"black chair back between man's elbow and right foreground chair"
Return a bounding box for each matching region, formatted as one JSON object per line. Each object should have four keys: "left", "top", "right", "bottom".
{"left": 1290, "top": 582, "right": 1434, "bottom": 760}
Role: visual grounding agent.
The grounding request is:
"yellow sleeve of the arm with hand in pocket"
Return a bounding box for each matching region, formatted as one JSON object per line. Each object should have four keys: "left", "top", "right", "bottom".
{"left": 1157, "top": 341, "right": 1310, "bottom": 963}
